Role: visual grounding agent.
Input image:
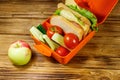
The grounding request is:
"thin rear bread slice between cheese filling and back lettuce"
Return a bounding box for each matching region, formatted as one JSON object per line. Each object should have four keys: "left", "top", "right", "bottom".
{"left": 58, "top": 3, "right": 91, "bottom": 36}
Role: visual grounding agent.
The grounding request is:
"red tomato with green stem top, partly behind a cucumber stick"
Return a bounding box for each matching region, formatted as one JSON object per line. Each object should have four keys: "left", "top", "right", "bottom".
{"left": 47, "top": 26, "right": 63, "bottom": 38}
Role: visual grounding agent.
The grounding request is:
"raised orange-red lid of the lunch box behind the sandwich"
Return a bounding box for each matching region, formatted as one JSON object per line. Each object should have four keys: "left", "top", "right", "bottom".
{"left": 75, "top": 0, "right": 118, "bottom": 24}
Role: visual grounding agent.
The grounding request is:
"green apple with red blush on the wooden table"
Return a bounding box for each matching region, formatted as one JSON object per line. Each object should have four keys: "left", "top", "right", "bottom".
{"left": 8, "top": 40, "right": 32, "bottom": 65}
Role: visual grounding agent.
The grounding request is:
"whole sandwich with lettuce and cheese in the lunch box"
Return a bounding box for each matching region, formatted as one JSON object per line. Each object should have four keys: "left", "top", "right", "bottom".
{"left": 50, "top": 0, "right": 97, "bottom": 40}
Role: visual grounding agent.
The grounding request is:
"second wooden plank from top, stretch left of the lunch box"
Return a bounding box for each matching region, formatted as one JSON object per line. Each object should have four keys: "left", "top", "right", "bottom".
{"left": 0, "top": 19, "right": 43, "bottom": 34}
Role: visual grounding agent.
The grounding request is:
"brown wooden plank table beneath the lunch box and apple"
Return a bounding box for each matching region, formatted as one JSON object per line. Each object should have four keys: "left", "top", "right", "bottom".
{"left": 0, "top": 0, "right": 120, "bottom": 80}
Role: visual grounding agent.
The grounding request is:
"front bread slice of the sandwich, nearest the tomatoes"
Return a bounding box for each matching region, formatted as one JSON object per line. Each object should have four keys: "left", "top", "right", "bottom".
{"left": 50, "top": 15, "right": 84, "bottom": 40}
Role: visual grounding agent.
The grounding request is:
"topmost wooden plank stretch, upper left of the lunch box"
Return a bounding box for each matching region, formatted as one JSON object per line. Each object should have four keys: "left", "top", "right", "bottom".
{"left": 0, "top": 1, "right": 57, "bottom": 19}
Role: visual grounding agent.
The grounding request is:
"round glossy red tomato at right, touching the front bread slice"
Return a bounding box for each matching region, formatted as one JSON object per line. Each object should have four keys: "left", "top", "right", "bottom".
{"left": 64, "top": 33, "right": 79, "bottom": 49}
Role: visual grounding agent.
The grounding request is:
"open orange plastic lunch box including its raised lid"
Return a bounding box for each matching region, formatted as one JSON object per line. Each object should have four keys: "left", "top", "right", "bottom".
{"left": 32, "top": 0, "right": 118, "bottom": 64}
